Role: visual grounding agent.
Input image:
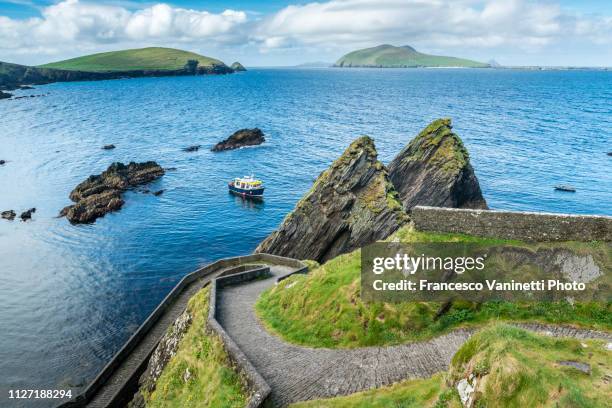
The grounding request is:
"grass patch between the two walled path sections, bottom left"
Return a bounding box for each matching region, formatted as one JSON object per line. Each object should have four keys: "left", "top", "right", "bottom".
{"left": 143, "top": 288, "right": 248, "bottom": 408}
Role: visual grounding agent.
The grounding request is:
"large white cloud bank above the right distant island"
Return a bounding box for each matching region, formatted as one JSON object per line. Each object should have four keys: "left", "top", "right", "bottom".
{"left": 254, "top": 0, "right": 612, "bottom": 54}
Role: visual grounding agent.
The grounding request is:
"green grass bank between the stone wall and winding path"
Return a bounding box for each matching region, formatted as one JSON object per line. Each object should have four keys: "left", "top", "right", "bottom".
{"left": 256, "top": 226, "right": 612, "bottom": 348}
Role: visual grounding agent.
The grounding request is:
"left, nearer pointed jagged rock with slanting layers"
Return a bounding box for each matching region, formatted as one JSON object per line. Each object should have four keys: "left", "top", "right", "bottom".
{"left": 256, "top": 136, "right": 408, "bottom": 262}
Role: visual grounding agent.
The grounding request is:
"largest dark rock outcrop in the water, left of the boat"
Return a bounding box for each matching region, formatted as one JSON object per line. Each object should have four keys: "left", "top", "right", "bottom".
{"left": 60, "top": 161, "right": 164, "bottom": 224}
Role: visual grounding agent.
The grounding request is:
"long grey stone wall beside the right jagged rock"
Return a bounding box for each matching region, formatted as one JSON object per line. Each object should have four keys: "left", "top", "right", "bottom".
{"left": 411, "top": 206, "right": 612, "bottom": 241}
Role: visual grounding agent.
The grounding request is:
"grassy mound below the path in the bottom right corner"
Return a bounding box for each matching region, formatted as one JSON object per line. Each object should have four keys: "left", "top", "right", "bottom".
{"left": 291, "top": 324, "right": 612, "bottom": 408}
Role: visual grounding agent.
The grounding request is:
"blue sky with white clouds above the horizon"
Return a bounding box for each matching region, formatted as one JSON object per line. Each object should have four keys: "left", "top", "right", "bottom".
{"left": 0, "top": 0, "right": 612, "bottom": 67}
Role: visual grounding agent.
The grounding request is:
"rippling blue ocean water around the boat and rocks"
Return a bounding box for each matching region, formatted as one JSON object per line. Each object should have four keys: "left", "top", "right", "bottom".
{"left": 0, "top": 69, "right": 612, "bottom": 406}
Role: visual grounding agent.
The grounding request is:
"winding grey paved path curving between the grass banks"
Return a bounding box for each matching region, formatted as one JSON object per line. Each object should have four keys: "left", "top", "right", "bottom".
{"left": 217, "top": 266, "right": 612, "bottom": 407}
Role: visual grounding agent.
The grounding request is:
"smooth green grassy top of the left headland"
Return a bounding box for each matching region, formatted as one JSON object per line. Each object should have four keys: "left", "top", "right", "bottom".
{"left": 40, "top": 47, "right": 224, "bottom": 72}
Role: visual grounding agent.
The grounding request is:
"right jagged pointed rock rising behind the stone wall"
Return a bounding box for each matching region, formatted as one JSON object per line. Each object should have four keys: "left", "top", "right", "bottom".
{"left": 389, "top": 119, "right": 487, "bottom": 211}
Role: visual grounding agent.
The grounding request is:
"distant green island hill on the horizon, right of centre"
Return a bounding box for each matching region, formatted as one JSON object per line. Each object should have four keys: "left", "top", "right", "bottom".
{"left": 334, "top": 44, "right": 489, "bottom": 68}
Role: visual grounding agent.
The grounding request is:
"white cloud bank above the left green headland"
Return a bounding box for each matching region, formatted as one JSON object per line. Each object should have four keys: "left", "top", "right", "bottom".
{"left": 0, "top": 0, "right": 247, "bottom": 51}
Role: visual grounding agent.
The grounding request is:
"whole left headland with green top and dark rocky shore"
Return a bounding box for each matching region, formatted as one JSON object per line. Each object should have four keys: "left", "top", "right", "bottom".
{"left": 0, "top": 47, "right": 234, "bottom": 90}
